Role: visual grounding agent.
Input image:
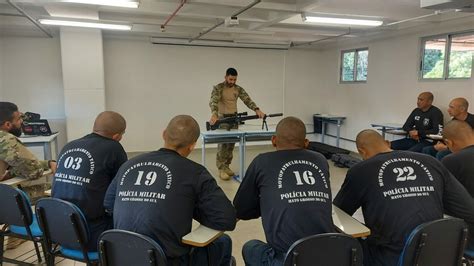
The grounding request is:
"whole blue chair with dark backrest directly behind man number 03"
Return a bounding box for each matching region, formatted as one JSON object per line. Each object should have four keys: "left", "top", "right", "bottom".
{"left": 36, "top": 198, "right": 99, "bottom": 266}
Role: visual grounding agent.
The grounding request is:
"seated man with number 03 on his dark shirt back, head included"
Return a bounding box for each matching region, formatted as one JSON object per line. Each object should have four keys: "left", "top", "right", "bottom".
{"left": 51, "top": 111, "right": 127, "bottom": 251}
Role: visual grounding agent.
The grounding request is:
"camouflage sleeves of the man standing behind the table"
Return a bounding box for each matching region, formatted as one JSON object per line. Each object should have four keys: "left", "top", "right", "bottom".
{"left": 209, "top": 82, "right": 258, "bottom": 115}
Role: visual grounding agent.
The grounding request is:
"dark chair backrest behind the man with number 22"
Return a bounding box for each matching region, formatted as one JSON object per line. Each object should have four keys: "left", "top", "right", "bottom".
{"left": 398, "top": 218, "right": 468, "bottom": 266}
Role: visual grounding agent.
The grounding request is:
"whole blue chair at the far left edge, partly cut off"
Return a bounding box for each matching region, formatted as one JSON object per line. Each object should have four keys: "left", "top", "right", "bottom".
{"left": 0, "top": 184, "right": 46, "bottom": 265}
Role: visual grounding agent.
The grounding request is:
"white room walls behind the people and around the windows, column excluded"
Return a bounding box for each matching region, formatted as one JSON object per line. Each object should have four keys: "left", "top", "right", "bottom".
{"left": 0, "top": 17, "right": 474, "bottom": 154}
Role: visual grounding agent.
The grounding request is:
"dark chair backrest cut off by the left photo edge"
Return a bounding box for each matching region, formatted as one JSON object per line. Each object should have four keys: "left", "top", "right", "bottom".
{"left": 0, "top": 184, "right": 33, "bottom": 226}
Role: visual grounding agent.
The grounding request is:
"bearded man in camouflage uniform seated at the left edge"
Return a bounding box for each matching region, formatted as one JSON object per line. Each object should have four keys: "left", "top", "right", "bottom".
{"left": 0, "top": 102, "right": 56, "bottom": 185}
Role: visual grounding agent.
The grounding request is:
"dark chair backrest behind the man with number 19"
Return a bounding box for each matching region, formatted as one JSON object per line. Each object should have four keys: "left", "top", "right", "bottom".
{"left": 98, "top": 229, "right": 167, "bottom": 266}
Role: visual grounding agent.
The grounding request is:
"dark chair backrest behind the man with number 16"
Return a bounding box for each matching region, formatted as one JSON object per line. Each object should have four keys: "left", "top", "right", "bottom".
{"left": 284, "top": 233, "right": 362, "bottom": 266}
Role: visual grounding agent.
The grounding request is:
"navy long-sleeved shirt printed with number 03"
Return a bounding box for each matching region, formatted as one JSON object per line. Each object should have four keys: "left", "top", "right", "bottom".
{"left": 52, "top": 133, "right": 127, "bottom": 222}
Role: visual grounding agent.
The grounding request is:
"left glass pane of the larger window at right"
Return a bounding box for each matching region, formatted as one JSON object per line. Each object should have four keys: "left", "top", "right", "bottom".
{"left": 422, "top": 38, "right": 446, "bottom": 79}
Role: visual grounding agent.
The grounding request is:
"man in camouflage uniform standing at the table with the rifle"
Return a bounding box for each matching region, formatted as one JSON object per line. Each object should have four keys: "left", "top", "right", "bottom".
{"left": 209, "top": 68, "right": 265, "bottom": 180}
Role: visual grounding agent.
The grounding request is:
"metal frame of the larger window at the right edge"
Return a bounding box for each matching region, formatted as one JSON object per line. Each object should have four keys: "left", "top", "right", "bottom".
{"left": 418, "top": 30, "right": 474, "bottom": 81}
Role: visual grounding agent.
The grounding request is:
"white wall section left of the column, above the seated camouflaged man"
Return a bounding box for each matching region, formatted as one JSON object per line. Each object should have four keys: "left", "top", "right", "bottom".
{"left": 0, "top": 37, "right": 66, "bottom": 151}
